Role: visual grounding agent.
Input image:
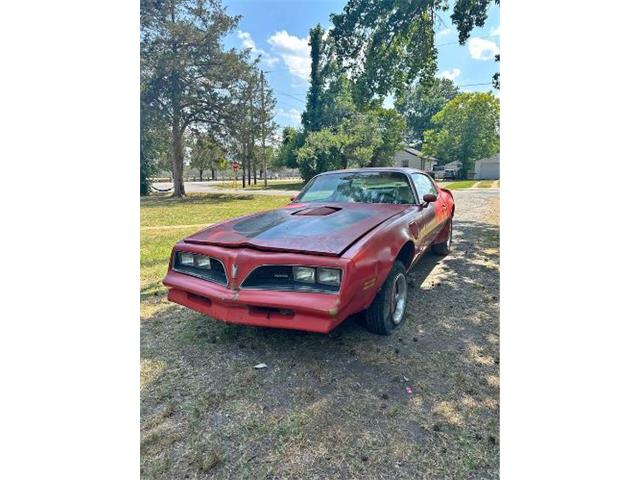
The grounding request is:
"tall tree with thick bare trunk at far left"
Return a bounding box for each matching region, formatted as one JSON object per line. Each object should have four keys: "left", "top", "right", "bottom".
{"left": 140, "top": 0, "right": 246, "bottom": 196}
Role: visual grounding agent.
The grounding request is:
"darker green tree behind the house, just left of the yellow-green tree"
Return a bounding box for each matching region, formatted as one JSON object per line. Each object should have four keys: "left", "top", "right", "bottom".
{"left": 394, "top": 78, "right": 460, "bottom": 148}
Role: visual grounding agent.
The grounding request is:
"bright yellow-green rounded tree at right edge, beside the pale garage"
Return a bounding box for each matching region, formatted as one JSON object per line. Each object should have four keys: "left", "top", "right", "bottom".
{"left": 422, "top": 92, "right": 500, "bottom": 176}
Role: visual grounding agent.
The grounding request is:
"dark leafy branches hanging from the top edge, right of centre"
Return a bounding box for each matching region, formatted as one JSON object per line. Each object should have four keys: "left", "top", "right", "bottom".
{"left": 331, "top": 0, "right": 499, "bottom": 102}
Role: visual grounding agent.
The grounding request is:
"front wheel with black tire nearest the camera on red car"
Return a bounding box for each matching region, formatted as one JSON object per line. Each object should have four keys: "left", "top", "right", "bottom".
{"left": 365, "top": 260, "right": 408, "bottom": 335}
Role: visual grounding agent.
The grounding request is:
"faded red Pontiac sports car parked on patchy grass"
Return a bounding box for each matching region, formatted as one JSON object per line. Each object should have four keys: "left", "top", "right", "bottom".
{"left": 164, "top": 168, "right": 455, "bottom": 335}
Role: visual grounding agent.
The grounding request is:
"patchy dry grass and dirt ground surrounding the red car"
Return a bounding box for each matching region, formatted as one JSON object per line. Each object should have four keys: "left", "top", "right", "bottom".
{"left": 140, "top": 189, "right": 499, "bottom": 479}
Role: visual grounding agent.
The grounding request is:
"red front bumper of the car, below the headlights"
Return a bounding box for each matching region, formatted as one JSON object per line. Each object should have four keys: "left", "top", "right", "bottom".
{"left": 163, "top": 270, "right": 351, "bottom": 333}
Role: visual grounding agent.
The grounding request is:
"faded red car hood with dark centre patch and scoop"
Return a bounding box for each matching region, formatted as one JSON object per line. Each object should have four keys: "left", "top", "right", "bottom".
{"left": 184, "top": 203, "right": 409, "bottom": 256}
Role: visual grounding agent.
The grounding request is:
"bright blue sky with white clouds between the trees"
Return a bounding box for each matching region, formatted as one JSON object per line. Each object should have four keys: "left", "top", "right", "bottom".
{"left": 223, "top": 0, "right": 500, "bottom": 127}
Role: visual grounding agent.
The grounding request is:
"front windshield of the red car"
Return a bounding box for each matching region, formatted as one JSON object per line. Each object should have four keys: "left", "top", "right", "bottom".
{"left": 297, "top": 172, "right": 415, "bottom": 204}
